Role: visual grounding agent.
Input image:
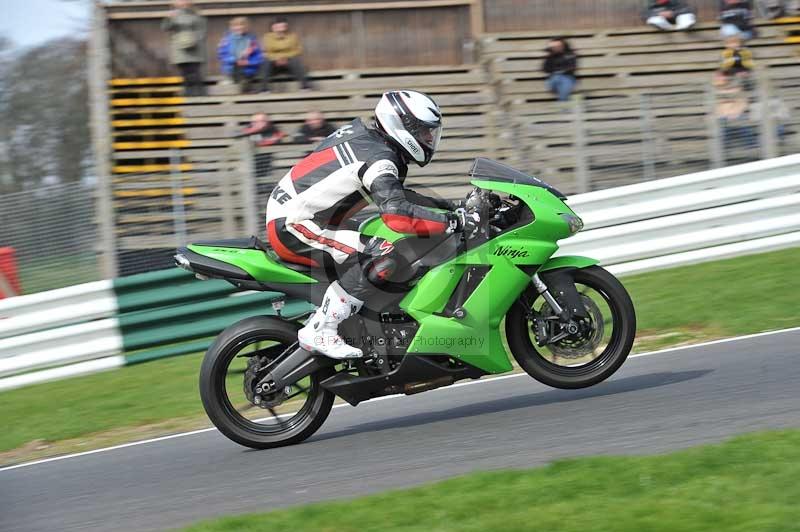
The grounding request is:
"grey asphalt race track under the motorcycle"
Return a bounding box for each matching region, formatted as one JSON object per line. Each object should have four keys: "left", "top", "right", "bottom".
{"left": 0, "top": 329, "right": 800, "bottom": 532}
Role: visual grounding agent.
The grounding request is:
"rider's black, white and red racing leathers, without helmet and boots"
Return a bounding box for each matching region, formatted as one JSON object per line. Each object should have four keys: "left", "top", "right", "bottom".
{"left": 267, "top": 119, "right": 458, "bottom": 300}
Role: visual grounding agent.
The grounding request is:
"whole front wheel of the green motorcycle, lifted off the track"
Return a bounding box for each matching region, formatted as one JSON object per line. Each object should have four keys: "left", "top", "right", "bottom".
{"left": 505, "top": 266, "right": 636, "bottom": 389}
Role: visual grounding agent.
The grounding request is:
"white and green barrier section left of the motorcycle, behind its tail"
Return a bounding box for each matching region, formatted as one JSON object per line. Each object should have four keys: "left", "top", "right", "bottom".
{"left": 0, "top": 268, "right": 311, "bottom": 390}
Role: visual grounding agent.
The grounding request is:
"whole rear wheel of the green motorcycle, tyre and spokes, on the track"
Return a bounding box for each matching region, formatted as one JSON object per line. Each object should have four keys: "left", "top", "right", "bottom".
{"left": 200, "top": 316, "right": 335, "bottom": 449}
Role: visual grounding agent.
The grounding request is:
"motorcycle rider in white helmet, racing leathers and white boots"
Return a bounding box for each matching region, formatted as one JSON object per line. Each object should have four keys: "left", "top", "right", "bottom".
{"left": 267, "top": 90, "right": 480, "bottom": 359}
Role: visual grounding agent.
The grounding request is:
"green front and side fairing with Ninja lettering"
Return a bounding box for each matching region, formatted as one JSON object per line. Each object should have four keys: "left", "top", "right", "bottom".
{"left": 400, "top": 180, "right": 580, "bottom": 373}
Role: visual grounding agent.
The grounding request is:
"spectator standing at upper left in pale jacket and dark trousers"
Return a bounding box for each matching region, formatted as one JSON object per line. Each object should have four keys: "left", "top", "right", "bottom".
{"left": 161, "top": 0, "right": 206, "bottom": 96}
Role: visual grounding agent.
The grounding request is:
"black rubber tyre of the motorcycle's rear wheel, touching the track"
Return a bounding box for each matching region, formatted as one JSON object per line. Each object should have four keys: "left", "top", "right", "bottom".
{"left": 200, "top": 316, "right": 335, "bottom": 449}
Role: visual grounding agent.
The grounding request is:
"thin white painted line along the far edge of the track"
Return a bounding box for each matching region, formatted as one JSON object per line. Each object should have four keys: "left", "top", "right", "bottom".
{"left": 0, "top": 327, "right": 800, "bottom": 473}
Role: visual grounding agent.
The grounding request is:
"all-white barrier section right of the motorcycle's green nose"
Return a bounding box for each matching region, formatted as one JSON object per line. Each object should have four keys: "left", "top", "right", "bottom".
{"left": 558, "top": 155, "right": 800, "bottom": 275}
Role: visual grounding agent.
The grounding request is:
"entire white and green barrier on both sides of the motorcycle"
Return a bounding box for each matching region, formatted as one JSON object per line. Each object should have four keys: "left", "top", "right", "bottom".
{"left": 0, "top": 155, "right": 800, "bottom": 390}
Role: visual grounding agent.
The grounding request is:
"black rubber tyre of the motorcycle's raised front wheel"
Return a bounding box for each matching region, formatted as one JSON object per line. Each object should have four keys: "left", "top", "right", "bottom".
{"left": 506, "top": 266, "right": 636, "bottom": 389}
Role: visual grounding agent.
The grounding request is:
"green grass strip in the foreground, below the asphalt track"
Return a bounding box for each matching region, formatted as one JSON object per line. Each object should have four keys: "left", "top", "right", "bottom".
{"left": 181, "top": 431, "right": 800, "bottom": 532}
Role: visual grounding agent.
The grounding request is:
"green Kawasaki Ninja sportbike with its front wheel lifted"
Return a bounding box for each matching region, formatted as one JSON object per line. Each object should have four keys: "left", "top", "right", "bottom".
{"left": 175, "top": 158, "right": 636, "bottom": 448}
